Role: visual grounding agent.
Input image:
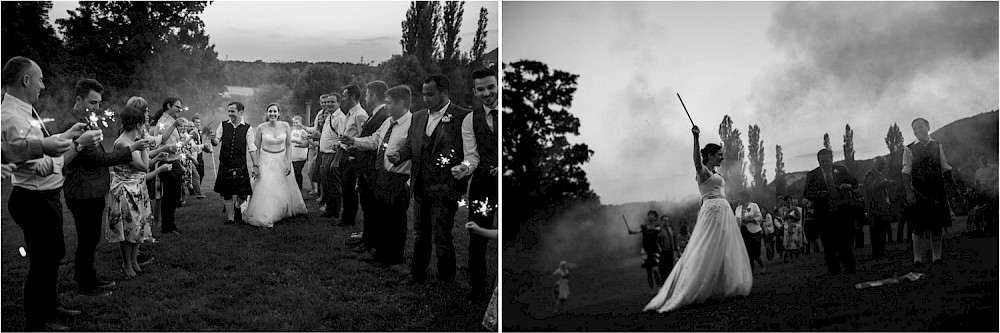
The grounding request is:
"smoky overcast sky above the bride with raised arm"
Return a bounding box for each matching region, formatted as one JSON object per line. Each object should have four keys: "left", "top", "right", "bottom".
{"left": 502, "top": 1, "right": 1000, "bottom": 204}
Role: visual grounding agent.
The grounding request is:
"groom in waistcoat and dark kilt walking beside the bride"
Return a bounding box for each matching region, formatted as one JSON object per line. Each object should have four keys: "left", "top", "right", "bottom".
{"left": 212, "top": 102, "right": 258, "bottom": 224}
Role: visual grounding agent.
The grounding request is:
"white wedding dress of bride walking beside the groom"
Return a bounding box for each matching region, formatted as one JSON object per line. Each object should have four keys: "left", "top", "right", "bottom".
{"left": 243, "top": 128, "right": 307, "bottom": 228}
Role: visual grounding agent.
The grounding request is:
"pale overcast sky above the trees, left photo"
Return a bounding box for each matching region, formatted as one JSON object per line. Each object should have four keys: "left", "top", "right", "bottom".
{"left": 49, "top": 1, "right": 499, "bottom": 64}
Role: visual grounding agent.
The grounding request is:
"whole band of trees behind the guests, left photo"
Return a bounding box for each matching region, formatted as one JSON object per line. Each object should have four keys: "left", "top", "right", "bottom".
{"left": 0, "top": 1, "right": 488, "bottom": 132}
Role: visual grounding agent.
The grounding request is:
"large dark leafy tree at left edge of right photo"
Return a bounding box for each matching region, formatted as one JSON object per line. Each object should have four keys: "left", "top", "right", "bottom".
{"left": 503, "top": 60, "right": 598, "bottom": 237}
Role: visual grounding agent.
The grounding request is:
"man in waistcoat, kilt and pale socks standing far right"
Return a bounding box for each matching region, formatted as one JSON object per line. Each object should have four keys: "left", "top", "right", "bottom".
{"left": 903, "top": 118, "right": 954, "bottom": 266}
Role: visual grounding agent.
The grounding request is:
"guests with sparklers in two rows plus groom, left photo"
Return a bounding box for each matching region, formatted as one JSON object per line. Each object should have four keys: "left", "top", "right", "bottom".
{"left": 2, "top": 57, "right": 499, "bottom": 331}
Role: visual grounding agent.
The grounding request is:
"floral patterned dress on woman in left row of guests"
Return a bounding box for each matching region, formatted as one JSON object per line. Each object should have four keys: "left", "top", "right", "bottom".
{"left": 104, "top": 164, "right": 153, "bottom": 243}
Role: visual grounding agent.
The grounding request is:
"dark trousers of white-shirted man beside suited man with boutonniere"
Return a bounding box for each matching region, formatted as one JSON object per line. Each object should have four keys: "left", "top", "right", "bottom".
{"left": 372, "top": 168, "right": 410, "bottom": 263}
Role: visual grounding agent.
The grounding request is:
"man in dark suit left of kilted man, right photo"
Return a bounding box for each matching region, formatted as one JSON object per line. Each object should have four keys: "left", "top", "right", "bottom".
{"left": 803, "top": 149, "right": 858, "bottom": 275}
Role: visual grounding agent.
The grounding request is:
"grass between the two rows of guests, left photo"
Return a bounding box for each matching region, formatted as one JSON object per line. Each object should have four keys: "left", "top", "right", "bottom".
{"left": 0, "top": 161, "right": 497, "bottom": 331}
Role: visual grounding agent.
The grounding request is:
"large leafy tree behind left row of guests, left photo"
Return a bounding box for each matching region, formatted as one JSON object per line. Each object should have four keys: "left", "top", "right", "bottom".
{"left": 56, "top": 1, "right": 225, "bottom": 110}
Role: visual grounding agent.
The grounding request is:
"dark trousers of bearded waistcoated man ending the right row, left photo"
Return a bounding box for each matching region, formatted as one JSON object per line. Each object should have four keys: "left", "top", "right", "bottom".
{"left": 469, "top": 168, "right": 499, "bottom": 291}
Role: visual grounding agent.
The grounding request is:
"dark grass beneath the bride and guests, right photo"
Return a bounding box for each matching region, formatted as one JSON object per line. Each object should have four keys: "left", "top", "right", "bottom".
{"left": 503, "top": 217, "right": 998, "bottom": 331}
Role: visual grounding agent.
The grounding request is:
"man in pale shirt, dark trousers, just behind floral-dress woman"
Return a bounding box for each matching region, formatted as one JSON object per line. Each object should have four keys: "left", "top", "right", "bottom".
{"left": 151, "top": 97, "right": 184, "bottom": 235}
